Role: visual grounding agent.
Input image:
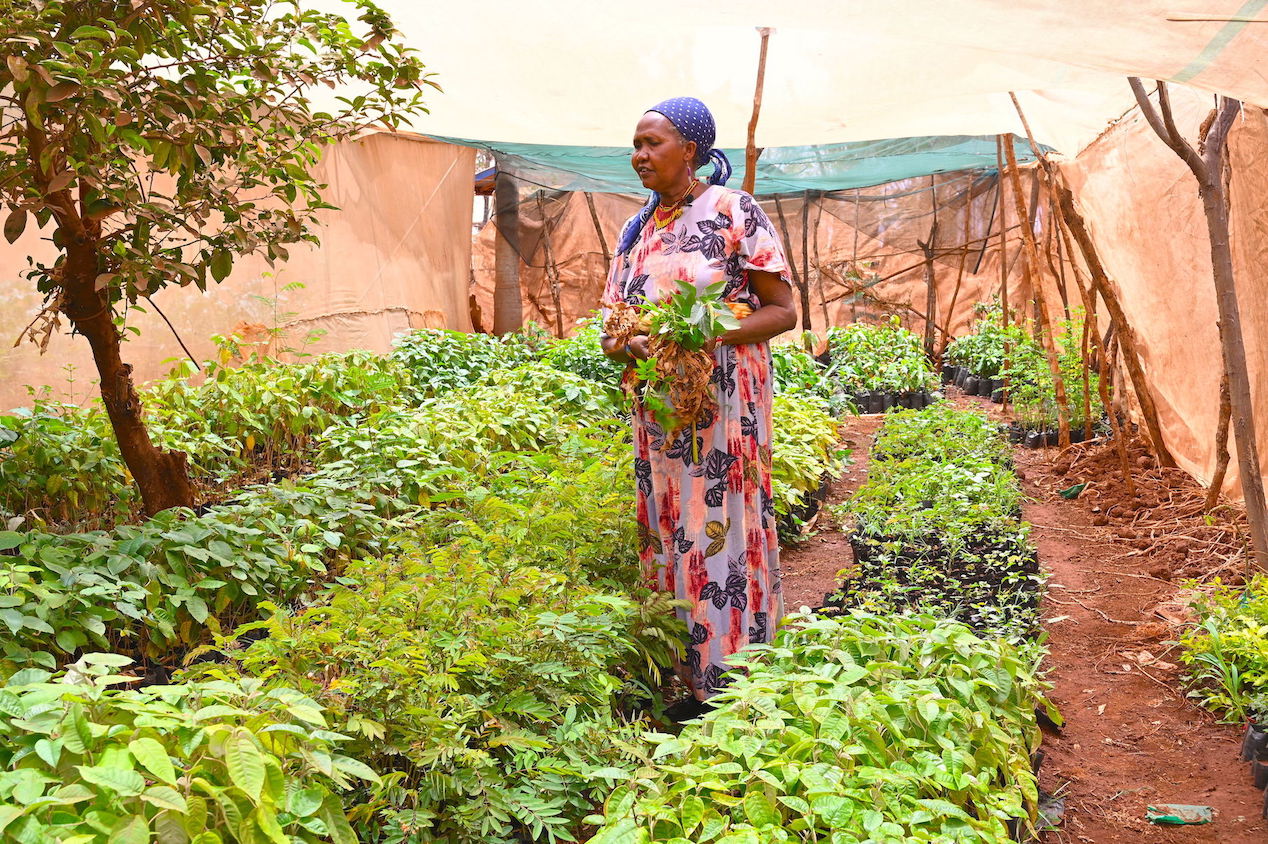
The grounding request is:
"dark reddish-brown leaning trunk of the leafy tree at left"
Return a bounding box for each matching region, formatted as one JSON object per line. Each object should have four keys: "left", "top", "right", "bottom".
{"left": 62, "top": 241, "right": 194, "bottom": 516}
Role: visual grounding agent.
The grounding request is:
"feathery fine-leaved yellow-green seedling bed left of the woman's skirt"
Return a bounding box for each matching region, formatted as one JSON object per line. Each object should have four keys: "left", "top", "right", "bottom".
{"left": 191, "top": 539, "right": 681, "bottom": 843}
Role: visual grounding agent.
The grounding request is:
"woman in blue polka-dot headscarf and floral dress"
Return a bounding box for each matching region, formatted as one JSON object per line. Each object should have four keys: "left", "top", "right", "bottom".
{"left": 602, "top": 98, "right": 796, "bottom": 720}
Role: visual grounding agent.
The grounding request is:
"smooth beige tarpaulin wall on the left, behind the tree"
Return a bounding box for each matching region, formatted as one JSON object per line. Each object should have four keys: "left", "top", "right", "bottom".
{"left": 0, "top": 133, "right": 476, "bottom": 409}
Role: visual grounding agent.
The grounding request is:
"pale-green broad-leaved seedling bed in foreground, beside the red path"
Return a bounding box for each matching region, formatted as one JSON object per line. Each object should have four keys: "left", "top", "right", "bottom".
{"left": 591, "top": 613, "right": 1045, "bottom": 844}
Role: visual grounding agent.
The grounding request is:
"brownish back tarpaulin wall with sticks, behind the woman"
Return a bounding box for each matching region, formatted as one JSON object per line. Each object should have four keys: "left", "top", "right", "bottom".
{"left": 472, "top": 172, "right": 1060, "bottom": 348}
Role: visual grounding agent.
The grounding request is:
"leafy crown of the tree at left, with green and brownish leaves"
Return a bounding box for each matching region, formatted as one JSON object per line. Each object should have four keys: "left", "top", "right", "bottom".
{"left": 0, "top": 0, "right": 432, "bottom": 303}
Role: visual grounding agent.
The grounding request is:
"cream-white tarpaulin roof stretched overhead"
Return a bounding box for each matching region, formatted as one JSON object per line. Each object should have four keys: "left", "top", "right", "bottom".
{"left": 332, "top": 0, "right": 1268, "bottom": 155}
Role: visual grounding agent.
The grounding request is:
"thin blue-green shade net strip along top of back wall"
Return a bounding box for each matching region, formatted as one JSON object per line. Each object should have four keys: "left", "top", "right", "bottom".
{"left": 437, "top": 134, "right": 1035, "bottom": 196}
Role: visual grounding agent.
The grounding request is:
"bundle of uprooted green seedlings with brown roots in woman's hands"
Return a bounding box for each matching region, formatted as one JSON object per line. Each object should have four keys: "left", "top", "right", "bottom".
{"left": 604, "top": 280, "right": 748, "bottom": 432}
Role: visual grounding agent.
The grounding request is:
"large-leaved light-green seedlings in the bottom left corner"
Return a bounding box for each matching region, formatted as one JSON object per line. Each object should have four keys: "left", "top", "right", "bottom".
{"left": 0, "top": 654, "right": 378, "bottom": 844}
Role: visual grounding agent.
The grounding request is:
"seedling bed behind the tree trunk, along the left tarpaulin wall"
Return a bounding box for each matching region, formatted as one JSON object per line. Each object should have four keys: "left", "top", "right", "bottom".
{"left": 0, "top": 351, "right": 410, "bottom": 531}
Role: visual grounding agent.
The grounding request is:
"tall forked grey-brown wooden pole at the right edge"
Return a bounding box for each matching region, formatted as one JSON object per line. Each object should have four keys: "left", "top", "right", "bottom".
{"left": 1129, "top": 76, "right": 1268, "bottom": 569}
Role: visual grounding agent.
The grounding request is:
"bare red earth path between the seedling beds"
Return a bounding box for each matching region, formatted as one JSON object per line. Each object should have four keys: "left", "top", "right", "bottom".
{"left": 782, "top": 390, "right": 1268, "bottom": 844}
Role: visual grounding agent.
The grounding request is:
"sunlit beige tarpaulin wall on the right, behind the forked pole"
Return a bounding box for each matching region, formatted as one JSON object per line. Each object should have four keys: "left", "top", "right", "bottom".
{"left": 1063, "top": 89, "right": 1268, "bottom": 489}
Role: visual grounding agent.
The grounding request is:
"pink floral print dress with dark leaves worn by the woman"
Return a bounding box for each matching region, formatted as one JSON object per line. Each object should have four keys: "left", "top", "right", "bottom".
{"left": 604, "top": 185, "right": 787, "bottom": 697}
